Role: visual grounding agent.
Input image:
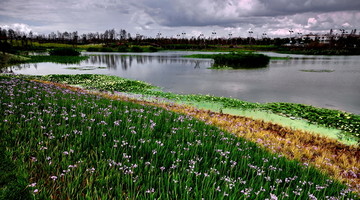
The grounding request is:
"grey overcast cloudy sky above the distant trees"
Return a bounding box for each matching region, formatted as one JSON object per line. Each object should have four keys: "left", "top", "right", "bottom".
{"left": 0, "top": 0, "right": 360, "bottom": 37}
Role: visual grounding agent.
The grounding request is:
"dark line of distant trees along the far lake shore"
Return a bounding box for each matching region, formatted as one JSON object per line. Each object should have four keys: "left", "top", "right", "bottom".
{"left": 0, "top": 28, "right": 360, "bottom": 51}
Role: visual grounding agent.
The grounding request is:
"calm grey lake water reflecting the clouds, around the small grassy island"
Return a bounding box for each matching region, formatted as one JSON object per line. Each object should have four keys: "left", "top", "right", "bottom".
{"left": 6, "top": 52, "right": 360, "bottom": 114}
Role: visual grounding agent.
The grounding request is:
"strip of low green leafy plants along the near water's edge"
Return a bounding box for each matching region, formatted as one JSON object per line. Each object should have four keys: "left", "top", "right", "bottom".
{"left": 21, "top": 74, "right": 360, "bottom": 143}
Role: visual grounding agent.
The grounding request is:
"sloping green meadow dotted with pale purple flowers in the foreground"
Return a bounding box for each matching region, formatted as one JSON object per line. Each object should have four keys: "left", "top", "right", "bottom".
{"left": 0, "top": 76, "right": 356, "bottom": 199}
